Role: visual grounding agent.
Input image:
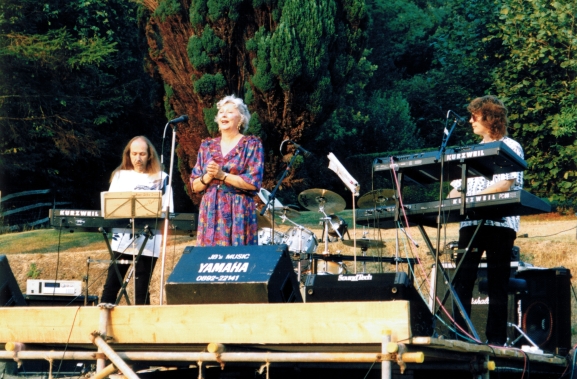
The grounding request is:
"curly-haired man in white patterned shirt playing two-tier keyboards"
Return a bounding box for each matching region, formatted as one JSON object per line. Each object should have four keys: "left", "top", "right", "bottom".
{"left": 449, "top": 96, "right": 523, "bottom": 346}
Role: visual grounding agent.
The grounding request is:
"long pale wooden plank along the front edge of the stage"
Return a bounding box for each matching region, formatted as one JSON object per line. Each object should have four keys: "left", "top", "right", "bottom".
{"left": 0, "top": 301, "right": 411, "bottom": 344}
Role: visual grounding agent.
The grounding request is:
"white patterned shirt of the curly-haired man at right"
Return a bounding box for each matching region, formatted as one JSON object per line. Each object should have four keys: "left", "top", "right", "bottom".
{"left": 451, "top": 137, "right": 524, "bottom": 232}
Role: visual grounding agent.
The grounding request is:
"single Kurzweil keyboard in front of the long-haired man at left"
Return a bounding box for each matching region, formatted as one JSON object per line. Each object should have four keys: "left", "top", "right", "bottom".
{"left": 49, "top": 209, "right": 197, "bottom": 235}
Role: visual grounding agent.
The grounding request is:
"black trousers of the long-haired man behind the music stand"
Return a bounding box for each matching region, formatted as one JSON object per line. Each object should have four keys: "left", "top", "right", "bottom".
{"left": 100, "top": 251, "right": 158, "bottom": 305}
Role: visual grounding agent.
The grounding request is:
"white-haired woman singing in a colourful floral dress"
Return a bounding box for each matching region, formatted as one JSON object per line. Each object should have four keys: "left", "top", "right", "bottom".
{"left": 190, "top": 95, "right": 264, "bottom": 246}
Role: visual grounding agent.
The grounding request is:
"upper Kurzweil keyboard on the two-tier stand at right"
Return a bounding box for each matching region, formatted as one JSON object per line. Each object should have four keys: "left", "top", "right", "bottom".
{"left": 373, "top": 141, "right": 527, "bottom": 184}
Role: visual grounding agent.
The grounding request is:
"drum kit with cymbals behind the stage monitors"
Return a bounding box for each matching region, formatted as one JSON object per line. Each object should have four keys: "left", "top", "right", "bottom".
{"left": 257, "top": 188, "right": 394, "bottom": 281}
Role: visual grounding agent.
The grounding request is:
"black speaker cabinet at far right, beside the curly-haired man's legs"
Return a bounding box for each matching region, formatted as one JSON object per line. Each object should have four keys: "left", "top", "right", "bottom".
{"left": 516, "top": 267, "right": 571, "bottom": 356}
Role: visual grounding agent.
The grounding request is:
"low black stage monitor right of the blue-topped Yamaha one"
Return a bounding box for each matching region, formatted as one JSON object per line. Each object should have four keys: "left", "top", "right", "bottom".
{"left": 305, "top": 272, "right": 433, "bottom": 336}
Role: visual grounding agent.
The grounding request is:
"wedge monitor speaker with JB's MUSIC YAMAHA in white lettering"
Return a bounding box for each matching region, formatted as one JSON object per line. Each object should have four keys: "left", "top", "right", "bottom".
{"left": 165, "top": 245, "right": 302, "bottom": 304}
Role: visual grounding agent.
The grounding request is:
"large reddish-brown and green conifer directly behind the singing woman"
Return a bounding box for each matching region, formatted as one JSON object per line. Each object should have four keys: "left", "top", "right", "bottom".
{"left": 142, "top": 0, "right": 366, "bottom": 200}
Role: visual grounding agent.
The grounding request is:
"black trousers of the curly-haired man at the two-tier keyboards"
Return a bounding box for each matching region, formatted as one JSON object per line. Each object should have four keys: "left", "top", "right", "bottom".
{"left": 453, "top": 225, "right": 517, "bottom": 345}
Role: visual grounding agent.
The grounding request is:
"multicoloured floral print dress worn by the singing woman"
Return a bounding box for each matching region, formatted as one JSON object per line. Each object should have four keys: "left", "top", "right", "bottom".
{"left": 191, "top": 136, "right": 264, "bottom": 246}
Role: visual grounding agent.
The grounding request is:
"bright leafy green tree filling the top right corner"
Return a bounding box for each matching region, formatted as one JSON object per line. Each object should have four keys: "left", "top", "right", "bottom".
{"left": 487, "top": 0, "right": 577, "bottom": 203}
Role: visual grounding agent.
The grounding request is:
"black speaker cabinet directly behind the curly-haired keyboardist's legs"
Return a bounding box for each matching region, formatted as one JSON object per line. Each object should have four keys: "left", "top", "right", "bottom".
{"left": 433, "top": 262, "right": 522, "bottom": 342}
